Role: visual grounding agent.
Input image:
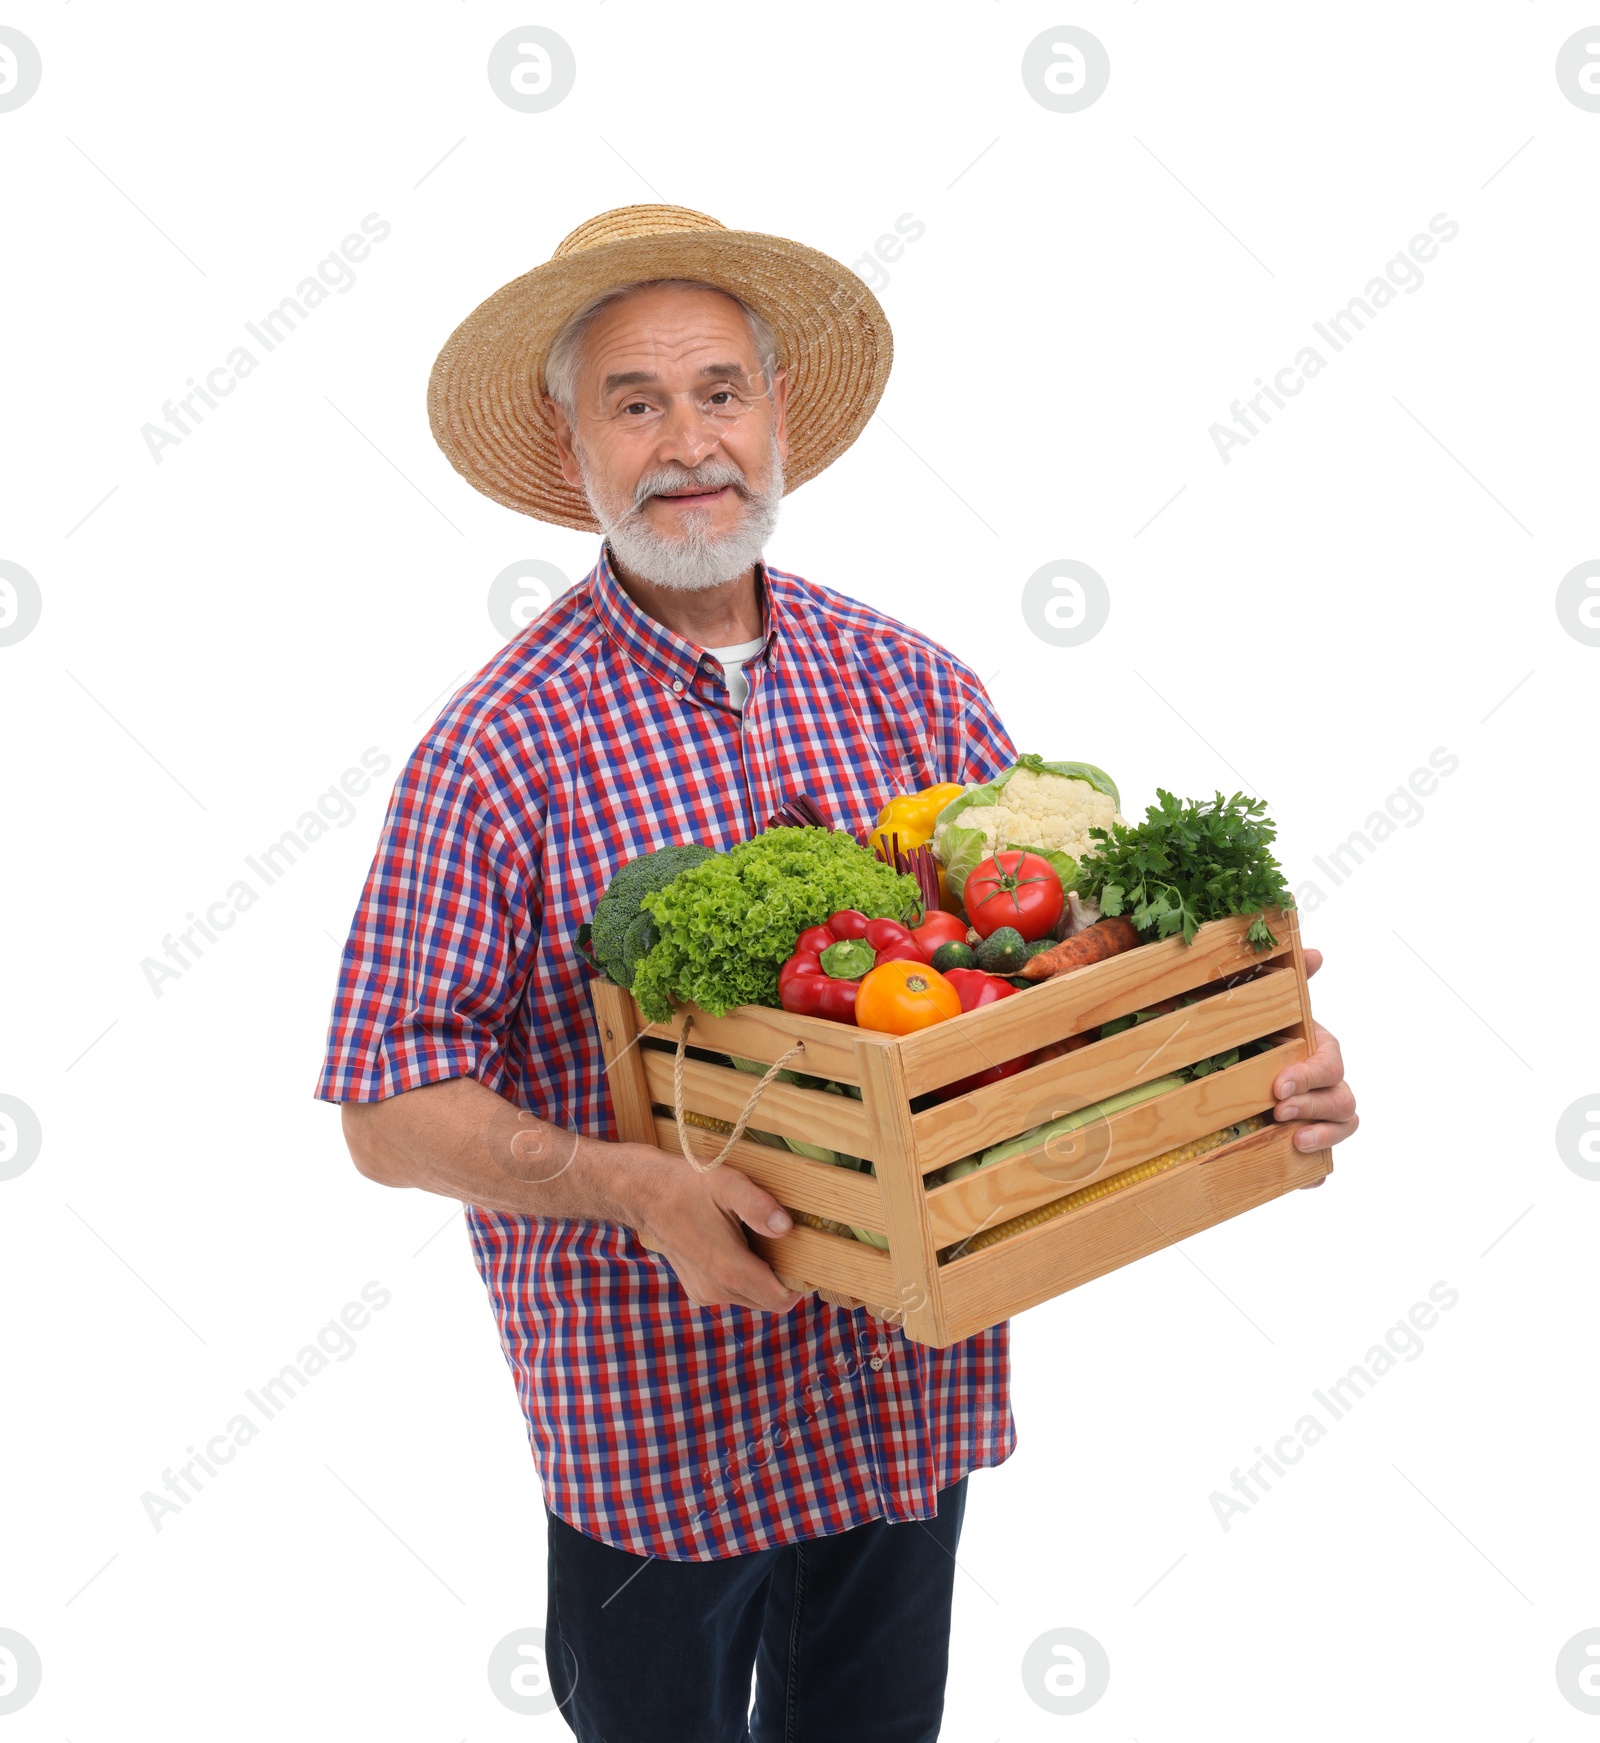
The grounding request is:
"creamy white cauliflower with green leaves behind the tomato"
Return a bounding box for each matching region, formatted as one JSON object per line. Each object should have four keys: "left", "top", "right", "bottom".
{"left": 932, "top": 756, "right": 1126, "bottom": 896}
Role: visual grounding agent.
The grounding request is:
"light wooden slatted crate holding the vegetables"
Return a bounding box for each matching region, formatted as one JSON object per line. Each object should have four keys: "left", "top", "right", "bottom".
{"left": 594, "top": 913, "right": 1333, "bottom": 1346}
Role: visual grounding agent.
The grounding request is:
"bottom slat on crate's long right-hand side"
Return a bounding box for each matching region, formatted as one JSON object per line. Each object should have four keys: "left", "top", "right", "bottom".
{"left": 939, "top": 1126, "right": 1332, "bottom": 1342}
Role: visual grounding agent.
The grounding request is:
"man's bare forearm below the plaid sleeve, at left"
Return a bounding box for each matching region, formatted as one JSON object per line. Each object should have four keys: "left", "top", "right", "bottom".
{"left": 342, "top": 1077, "right": 671, "bottom": 1227}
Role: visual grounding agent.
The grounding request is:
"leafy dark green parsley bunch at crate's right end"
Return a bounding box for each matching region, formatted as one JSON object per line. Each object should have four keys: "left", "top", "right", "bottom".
{"left": 1079, "top": 788, "right": 1295, "bottom": 950}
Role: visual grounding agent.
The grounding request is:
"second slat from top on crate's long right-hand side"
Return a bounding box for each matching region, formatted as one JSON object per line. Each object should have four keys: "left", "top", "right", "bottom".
{"left": 912, "top": 967, "right": 1300, "bottom": 1173}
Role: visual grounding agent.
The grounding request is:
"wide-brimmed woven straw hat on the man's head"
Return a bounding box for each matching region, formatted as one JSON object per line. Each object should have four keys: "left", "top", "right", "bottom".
{"left": 427, "top": 206, "right": 894, "bottom": 532}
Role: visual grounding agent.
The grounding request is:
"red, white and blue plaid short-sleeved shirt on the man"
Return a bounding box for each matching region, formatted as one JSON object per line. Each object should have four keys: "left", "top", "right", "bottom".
{"left": 317, "top": 551, "right": 1016, "bottom": 1560}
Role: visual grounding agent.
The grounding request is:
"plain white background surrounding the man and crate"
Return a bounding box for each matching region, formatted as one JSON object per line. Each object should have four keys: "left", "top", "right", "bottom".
{"left": 0, "top": 0, "right": 1600, "bottom": 1743}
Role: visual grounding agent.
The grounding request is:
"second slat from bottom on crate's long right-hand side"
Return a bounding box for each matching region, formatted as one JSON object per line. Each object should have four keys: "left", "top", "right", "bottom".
{"left": 927, "top": 1039, "right": 1305, "bottom": 1246}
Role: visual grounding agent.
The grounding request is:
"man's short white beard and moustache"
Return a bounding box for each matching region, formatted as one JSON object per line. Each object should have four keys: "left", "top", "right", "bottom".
{"left": 577, "top": 432, "right": 783, "bottom": 593}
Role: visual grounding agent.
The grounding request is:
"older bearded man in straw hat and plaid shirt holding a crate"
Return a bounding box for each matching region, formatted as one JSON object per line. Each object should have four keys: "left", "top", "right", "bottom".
{"left": 319, "top": 206, "right": 1356, "bottom": 1743}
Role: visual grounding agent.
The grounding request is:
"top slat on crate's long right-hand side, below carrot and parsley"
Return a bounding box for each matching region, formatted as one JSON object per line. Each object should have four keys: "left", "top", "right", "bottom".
{"left": 899, "top": 913, "right": 1292, "bottom": 1095}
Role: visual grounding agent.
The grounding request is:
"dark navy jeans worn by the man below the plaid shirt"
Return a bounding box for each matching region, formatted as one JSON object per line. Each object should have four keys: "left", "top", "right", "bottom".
{"left": 544, "top": 1478, "right": 967, "bottom": 1743}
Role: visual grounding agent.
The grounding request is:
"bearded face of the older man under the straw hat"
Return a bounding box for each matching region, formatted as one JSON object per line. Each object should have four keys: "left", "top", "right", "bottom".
{"left": 547, "top": 289, "right": 788, "bottom": 587}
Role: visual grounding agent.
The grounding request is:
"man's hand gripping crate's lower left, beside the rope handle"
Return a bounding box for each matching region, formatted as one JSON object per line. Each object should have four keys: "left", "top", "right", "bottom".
{"left": 629, "top": 1145, "right": 802, "bottom": 1312}
